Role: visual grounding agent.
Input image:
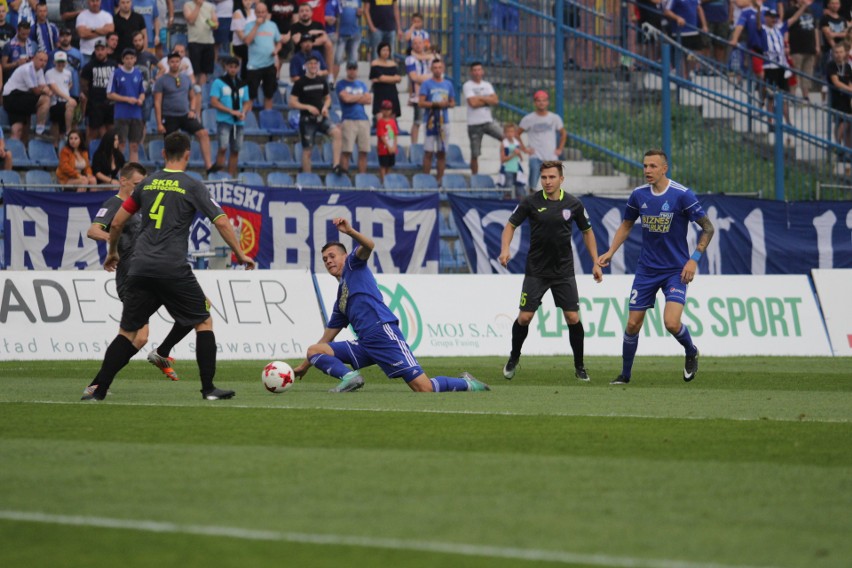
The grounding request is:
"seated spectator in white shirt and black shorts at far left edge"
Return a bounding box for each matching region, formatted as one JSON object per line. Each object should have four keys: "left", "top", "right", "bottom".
{"left": 3, "top": 51, "right": 51, "bottom": 145}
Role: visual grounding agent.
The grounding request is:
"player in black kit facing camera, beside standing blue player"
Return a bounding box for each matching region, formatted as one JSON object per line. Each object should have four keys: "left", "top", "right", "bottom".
{"left": 499, "top": 161, "right": 603, "bottom": 381}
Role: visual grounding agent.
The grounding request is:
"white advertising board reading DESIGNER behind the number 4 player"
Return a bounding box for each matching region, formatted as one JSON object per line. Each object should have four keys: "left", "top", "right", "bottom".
{"left": 0, "top": 270, "right": 323, "bottom": 360}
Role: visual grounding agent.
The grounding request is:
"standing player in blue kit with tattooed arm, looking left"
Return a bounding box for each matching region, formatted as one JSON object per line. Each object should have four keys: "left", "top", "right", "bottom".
{"left": 598, "top": 150, "right": 715, "bottom": 385}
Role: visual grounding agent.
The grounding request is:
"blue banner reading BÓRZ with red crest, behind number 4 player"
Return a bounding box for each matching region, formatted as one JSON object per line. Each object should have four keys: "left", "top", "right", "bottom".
{"left": 4, "top": 186, "right": 439, "bottom": 274}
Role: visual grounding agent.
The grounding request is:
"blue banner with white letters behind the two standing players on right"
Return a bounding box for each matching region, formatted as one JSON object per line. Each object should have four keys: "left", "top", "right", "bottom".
{"left": 450, "top": 194, "right": 852, "bottom": 274}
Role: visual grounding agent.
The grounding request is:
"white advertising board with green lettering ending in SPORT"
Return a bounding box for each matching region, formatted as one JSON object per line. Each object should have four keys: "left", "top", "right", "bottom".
{"left": 317, "top": 274, "right": 832, "bottom": 356}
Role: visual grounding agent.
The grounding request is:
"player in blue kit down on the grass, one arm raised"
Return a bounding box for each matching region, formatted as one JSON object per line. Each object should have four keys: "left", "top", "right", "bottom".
{"left": 294, "top": 218, "right": 491, "bottom": 392}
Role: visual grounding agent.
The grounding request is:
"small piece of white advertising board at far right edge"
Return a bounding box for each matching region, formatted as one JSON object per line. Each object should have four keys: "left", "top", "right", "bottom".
{"left": 811, "top": 268, "right": 852, "bottom": 356}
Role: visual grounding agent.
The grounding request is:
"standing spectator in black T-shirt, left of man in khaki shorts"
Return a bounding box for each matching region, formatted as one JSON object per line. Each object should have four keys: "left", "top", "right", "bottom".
{"left": 289, "top": 56, "right": 349, "bottom": 174}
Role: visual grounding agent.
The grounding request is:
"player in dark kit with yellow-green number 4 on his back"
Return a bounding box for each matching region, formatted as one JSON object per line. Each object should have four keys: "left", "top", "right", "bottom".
{"left": 82, "top": 132, "right": 255, "bottom": 400}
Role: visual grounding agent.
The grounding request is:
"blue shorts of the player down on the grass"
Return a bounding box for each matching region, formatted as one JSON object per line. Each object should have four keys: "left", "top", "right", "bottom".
{"left": 329, "top": 323, "right": 423, "bottom": 383}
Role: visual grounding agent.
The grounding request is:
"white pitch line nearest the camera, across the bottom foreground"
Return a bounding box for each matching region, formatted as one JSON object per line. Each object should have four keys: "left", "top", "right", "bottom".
{"left": 0, "top": 510, "right": 780, "bottom": 568}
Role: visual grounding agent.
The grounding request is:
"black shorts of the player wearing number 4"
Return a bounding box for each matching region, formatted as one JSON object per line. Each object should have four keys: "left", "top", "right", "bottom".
{"left": 121, "top": 272, "right": 210, "bottom": 331}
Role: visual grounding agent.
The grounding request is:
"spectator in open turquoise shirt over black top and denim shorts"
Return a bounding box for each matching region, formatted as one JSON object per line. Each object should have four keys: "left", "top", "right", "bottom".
{"left": 210, "top": 56, "right": 251, "bottom": 178}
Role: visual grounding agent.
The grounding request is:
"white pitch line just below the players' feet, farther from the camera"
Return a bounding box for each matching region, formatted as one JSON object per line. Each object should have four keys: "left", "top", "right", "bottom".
{"left": 0, "top": 399, "right": 852, "bottom": 424}
